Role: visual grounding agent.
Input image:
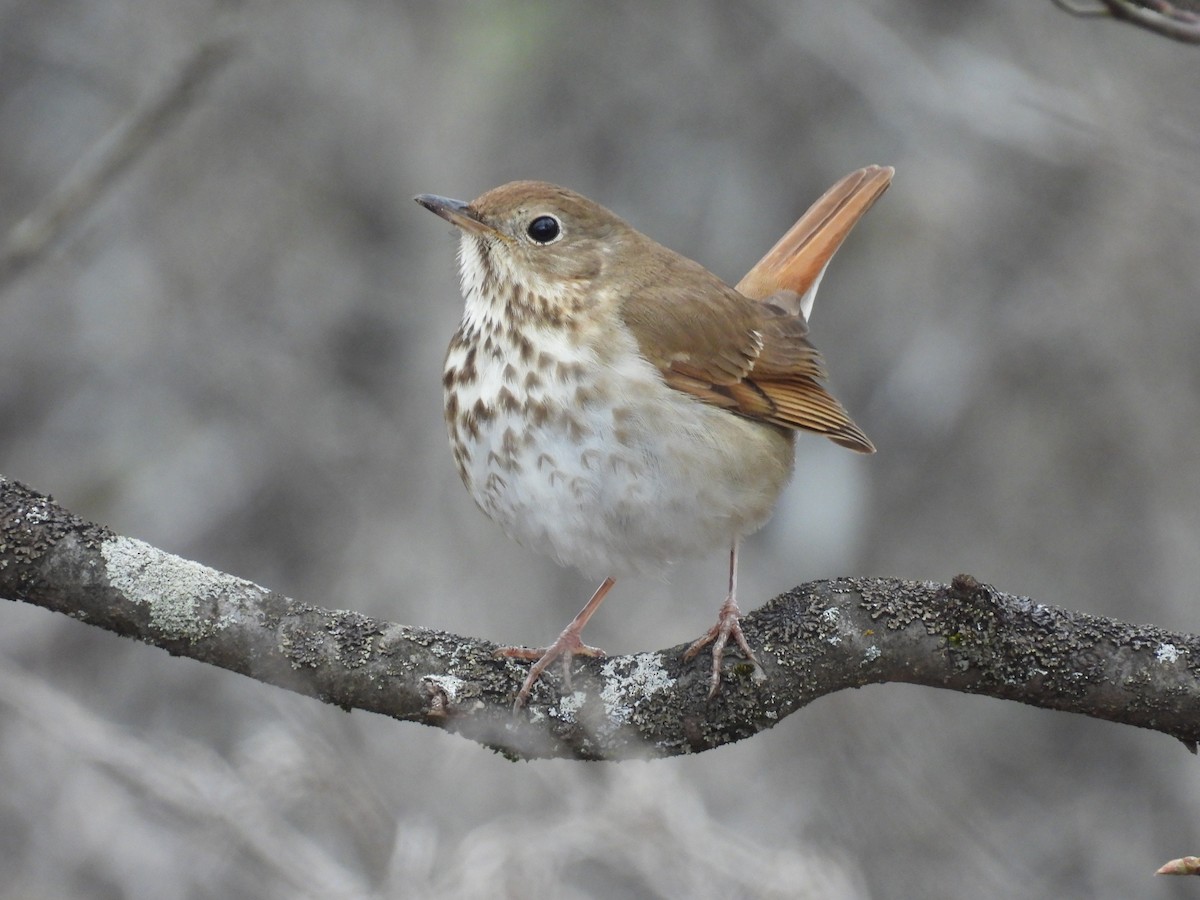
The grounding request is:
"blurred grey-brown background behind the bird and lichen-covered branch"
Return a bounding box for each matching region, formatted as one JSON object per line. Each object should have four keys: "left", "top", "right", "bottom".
{"left": 0, "top": 0, "right": 1200, "bottom": 899}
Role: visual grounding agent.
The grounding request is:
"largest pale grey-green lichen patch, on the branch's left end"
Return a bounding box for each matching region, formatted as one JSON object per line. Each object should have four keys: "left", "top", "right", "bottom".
{"left": 100, "top": 536, "right": 263, "bottom": 642}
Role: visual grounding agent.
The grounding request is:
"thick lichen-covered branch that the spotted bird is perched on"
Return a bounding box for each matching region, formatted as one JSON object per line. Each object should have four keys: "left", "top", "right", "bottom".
{"left": 0, "top": 475, "right": 1200, "bottom": 760}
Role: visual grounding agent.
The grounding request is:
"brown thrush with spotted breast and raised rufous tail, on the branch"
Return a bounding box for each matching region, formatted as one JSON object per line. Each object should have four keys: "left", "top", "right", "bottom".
{"left": 416, "top": 166, "right": 893, "bottom": 707}
